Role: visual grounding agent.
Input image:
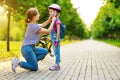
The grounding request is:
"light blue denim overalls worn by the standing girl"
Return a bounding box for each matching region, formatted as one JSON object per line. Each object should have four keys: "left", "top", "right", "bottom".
{"left": 51, "top": 30, "right": 61, "bottom": 64}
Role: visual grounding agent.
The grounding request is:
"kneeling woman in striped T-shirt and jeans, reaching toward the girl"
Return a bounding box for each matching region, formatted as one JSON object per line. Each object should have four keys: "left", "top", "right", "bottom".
{"left": 12, "top": 8, "right": 56, "bottom": 72}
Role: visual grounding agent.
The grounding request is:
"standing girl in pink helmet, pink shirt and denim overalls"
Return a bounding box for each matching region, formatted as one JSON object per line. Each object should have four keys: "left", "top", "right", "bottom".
{"left": 48, "top": 4, "right": 61, "bottom": 71}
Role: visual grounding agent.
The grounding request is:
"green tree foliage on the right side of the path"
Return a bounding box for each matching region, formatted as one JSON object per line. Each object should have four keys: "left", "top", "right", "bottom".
{"left": 91, "top": 0, "right": 120, "bottom": 39}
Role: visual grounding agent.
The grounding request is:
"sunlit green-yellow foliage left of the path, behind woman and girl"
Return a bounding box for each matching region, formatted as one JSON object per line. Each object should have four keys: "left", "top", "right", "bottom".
{"left": 0, "top": 0, "right": 89, "bottom": 41}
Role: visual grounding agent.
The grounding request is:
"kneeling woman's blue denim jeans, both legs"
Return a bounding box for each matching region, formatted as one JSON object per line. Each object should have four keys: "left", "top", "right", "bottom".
{"left": 20, "top": 45, "right": 48, "bottom": 71}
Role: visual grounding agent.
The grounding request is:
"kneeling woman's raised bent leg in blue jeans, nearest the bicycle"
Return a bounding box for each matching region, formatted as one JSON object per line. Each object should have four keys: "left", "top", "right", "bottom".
{"left": 34, "top": 47, "right": 48, "bottom": 61}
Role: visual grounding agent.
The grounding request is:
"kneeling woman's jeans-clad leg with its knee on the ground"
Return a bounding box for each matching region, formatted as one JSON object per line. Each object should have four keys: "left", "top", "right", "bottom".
{"left": 20, "top": 46, "right": 38, "bottom": 71}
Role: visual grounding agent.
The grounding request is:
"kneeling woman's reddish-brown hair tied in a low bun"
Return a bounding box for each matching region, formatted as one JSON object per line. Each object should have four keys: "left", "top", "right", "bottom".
{"left": 25, "top": 8, "right": 38, "bottom": 23}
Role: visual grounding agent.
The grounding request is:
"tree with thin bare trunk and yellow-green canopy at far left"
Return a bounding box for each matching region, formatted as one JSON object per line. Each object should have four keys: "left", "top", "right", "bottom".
{"left": 0, "top": 0, "right": 50, "bottom": 51}
